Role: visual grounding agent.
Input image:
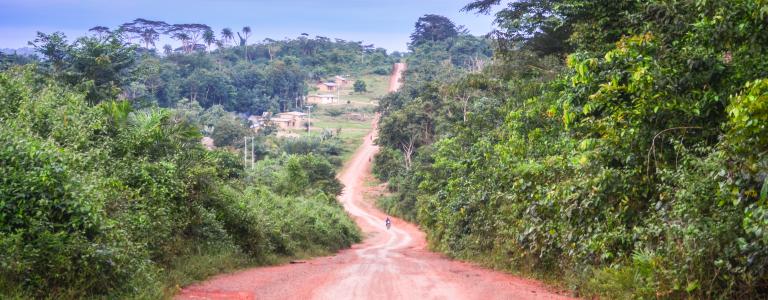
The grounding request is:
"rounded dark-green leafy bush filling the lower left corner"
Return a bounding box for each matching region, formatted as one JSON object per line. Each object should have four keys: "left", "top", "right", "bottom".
{"left": 0, "top": 128, "right": 147, "bottom": 297}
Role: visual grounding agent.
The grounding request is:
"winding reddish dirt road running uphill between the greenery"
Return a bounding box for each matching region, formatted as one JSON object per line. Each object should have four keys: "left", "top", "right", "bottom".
{"left": 177, "top": 64, "right": 568, "bottom": 299}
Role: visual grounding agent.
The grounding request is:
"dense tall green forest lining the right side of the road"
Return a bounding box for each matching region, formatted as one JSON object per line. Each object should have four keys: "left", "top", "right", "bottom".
{"left": 374, "top": 0, "right": 768, "bottom": 299}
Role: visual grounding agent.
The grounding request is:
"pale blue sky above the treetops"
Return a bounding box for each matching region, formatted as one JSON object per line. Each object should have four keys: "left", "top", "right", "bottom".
{"left": 0, "top": 0, "right": 492, "bottom": 51}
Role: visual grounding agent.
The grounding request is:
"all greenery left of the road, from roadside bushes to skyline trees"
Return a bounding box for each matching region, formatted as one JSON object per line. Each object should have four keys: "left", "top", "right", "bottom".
{"left": 0, "top": 20, "right": 397, "bottom": 299}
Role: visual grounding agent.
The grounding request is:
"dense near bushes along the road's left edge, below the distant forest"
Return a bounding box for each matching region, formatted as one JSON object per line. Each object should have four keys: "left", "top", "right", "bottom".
{"left": 0, "top": 67, "right": 359, "bottom": 299}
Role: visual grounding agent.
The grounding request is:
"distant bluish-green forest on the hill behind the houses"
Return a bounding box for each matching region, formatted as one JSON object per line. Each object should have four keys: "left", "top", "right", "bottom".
{"left": 0, "top": 18, "right": 403, "bottom": 115}
